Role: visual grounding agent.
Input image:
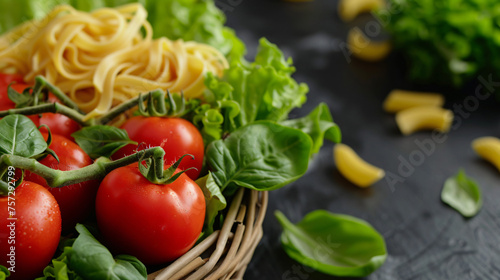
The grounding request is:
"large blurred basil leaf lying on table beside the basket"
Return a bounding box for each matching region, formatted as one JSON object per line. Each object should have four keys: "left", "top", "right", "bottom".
{"left": 275, "top": 210, "right": 387, "bottom": 277}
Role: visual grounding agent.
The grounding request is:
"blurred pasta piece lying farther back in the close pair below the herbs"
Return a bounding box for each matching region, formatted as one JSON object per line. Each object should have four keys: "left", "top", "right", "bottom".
{"left": 383, "top": 89, "right": 444, "bottom": 113}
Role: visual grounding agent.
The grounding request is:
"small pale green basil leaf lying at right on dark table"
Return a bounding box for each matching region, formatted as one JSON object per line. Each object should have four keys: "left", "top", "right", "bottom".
{"left": 441, "top": 170, "right": 483, "bottom": 217}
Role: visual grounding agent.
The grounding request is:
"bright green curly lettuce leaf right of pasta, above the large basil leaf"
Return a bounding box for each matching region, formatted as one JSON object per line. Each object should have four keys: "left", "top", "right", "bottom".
{"left": 195, "top": 38, "right": 309, "bottom": 140}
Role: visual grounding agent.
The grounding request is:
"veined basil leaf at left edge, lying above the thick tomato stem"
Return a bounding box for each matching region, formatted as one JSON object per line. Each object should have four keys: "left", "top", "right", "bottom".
{"left": 0, "top": 115, "right": 47, "bottom": 157}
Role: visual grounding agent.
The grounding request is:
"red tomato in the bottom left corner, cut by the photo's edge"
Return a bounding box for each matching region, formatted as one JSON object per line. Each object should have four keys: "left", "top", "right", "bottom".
{"left": 0, "top": 181, "right": 61, "bottom": 280}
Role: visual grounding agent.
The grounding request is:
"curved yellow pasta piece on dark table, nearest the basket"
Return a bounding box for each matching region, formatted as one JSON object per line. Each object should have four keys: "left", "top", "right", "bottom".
{"left": 333, "top": 143, "right": 385, "bottom": 188}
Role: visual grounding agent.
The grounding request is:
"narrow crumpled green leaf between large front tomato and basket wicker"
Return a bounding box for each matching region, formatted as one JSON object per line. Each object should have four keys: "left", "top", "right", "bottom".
{"left": 196, "top": 172, "right": 227, "bottom": 236}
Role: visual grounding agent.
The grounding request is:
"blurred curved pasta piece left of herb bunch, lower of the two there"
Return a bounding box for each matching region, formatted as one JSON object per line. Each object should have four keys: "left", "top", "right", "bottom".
{"left": 347, "top": 27, "right": 392, "bottom": 62}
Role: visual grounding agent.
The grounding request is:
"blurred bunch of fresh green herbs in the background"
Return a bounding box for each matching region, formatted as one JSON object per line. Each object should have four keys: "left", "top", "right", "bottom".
{"left": 377, "top": 0, "right": 500, "bottom": 87}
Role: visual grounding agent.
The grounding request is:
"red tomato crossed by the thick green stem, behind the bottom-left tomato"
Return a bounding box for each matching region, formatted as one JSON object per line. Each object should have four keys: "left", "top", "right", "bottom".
{"left": 25, "top": 133, "right": 99, "bottom": 231}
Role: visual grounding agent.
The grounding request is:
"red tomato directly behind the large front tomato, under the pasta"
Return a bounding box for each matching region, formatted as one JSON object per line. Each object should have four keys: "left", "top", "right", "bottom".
{"left": 113, "top": 116, "right": 205, "bottom": 180}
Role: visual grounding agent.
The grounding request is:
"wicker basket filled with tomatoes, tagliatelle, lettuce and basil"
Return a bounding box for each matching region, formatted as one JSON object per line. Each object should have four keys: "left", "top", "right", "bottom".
{"left": 0, "top": 0, "right": 340, "bottom": 280}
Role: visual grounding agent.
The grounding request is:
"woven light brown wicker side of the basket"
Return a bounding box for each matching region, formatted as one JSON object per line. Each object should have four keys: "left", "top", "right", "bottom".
{"left": 148, "top": 188, "right": 268, "bottom": 280}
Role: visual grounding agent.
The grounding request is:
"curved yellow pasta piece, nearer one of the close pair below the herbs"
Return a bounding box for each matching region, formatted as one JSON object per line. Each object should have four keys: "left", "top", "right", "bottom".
{"left": 396, "top": 107, "right": 453, "bottom": 135}
